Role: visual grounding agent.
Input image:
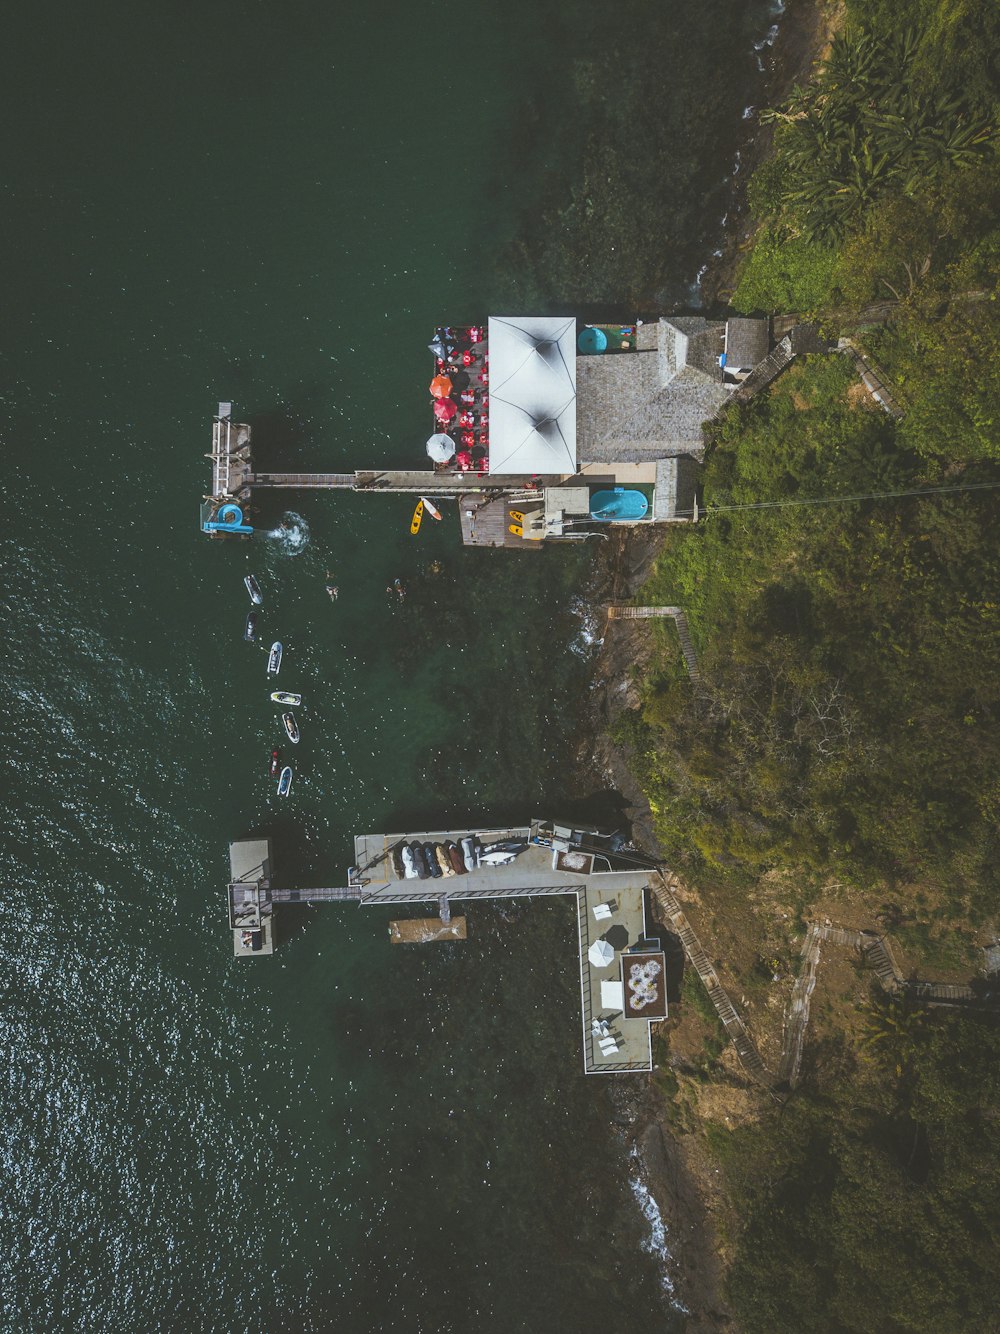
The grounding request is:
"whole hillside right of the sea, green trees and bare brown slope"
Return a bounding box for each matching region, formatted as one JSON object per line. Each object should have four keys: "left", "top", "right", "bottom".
{"left": 581, "top": 0, "right": 1000, "bottom": 1334}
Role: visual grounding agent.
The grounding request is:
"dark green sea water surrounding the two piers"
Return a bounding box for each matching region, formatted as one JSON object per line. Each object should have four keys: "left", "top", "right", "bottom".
{"left": 0, "top": 0, "right": 767, "bottom": 1334}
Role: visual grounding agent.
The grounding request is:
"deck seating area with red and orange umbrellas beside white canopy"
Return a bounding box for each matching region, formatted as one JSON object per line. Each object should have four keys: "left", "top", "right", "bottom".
{"left": 427, "top": 324, "right": 489, "bottom": 476}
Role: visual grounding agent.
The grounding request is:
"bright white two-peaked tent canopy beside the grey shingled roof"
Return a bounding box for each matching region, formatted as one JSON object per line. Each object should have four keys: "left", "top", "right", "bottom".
{"left": 489, "top": 315, "right": 576, "bottom": 475}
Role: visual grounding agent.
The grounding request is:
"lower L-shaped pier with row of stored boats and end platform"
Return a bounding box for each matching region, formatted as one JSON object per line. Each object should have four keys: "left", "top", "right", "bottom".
{"left": 229, "top": 819, "right": 667, "bottom": 1074}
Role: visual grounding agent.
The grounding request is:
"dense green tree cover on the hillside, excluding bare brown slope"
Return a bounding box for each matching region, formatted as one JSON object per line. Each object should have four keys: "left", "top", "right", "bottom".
{"left": 619, "top": 0, "right": 1000, "bottom": 1334}
